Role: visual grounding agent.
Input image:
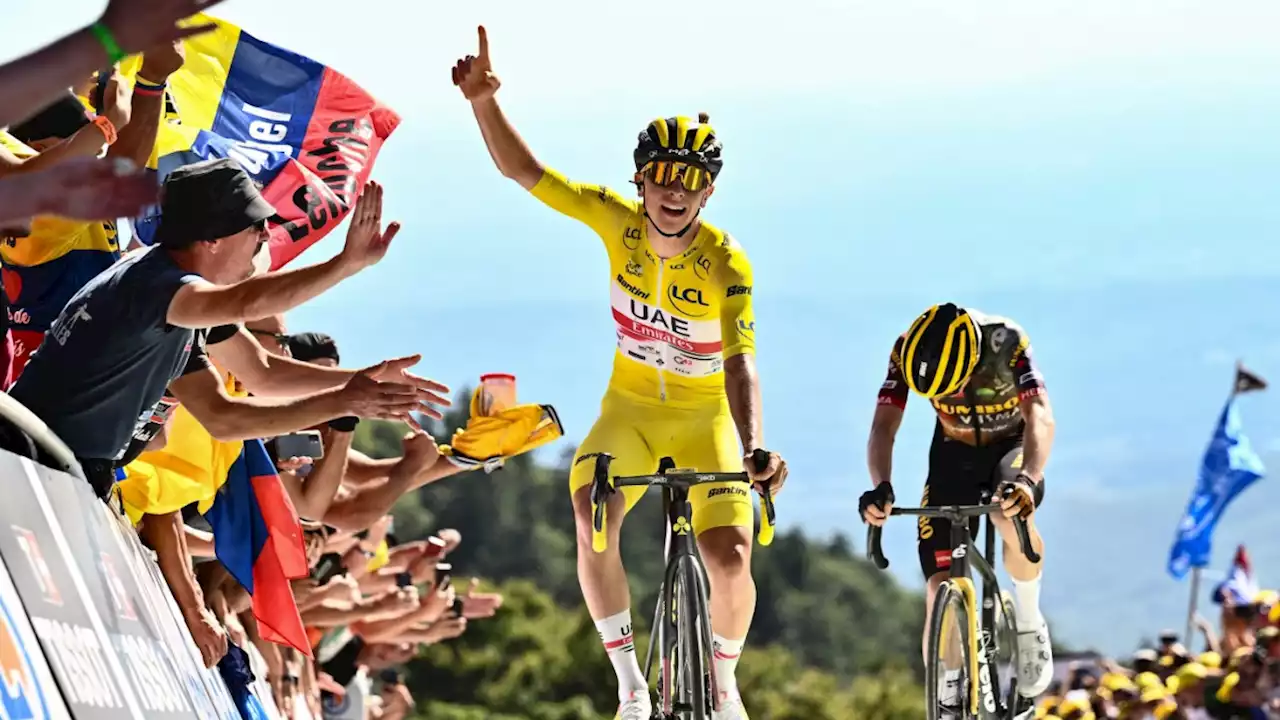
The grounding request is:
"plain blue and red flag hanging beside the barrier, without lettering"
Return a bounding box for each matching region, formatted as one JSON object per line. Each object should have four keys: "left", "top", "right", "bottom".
{"left": 205, "top": 439, "right": 311, "bottom": 657}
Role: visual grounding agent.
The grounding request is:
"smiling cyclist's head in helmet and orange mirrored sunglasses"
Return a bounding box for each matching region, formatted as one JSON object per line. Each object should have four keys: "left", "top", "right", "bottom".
{"left": 634, "top": 113, "right": 723, "bottom": 237}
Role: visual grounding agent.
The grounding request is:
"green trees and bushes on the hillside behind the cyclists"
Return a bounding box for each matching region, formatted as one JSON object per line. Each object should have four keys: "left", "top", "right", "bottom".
{"left": 356, "top": 393, "right": 924, "bottom": 720}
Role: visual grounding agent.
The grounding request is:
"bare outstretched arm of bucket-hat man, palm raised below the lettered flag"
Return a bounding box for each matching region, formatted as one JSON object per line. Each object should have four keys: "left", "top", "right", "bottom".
{"left": 166, "top": 182, "right": 399, "bottom": 328}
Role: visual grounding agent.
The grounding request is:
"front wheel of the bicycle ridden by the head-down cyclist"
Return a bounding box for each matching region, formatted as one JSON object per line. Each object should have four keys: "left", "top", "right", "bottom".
{"left": 924, "top": 580, "right": 977, "bottom": 720}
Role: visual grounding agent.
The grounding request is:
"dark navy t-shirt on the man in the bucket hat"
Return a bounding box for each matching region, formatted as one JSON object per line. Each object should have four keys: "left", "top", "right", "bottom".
{"left": 9, "top": 247, "right": 205, "bottom": 460}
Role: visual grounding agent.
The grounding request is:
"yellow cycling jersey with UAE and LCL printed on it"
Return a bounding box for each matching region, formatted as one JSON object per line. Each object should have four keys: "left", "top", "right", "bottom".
{"left": 531, "top": 169, "right": 755, "bottom": 405}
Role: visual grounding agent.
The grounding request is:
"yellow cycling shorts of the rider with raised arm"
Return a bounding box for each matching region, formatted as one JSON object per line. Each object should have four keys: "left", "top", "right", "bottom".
{"left": 568, "top": 391, "right": 755, "bottom": 534}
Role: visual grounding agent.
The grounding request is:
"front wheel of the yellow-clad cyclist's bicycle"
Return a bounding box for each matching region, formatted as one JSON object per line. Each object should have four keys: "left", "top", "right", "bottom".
{"left": 672, "top": 557, "right": 712, "bottom": 720}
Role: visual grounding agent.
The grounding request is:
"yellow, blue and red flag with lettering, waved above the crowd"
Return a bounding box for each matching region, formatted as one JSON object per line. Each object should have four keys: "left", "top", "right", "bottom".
{"left": 131, "top": 15, "right": 399, "bottom": 270}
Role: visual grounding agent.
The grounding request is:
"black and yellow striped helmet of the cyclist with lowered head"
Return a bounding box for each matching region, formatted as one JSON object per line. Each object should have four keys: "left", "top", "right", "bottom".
{"left": 900, "top": 302, "right": 982, "bottom": 398}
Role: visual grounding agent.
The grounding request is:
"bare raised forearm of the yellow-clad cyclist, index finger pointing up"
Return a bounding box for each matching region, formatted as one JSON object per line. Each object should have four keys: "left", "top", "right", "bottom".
{"left": 453, "top": 26, "right": 543, "bottom": 190}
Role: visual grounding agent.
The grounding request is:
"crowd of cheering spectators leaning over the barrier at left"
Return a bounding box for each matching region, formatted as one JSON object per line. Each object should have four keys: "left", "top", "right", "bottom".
{"left": 0, "top": 0, "right": 502, "bottom": 720}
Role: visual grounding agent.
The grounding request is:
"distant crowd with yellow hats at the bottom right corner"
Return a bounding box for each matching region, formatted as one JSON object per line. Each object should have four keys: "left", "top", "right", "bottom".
{"left": 1036, "top": 591, "right": 1280, "bottom": 720}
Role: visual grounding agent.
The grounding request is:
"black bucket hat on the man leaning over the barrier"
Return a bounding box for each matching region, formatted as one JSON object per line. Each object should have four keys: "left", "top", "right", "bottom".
{"left": 156, "top": 158, "right": 275, "bottom": 247}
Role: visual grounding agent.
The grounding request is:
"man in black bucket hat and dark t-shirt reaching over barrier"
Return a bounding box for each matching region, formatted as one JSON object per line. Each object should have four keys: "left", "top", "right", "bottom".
{"left": 10, "top": 159, "right": 448, "bottom": 497}
